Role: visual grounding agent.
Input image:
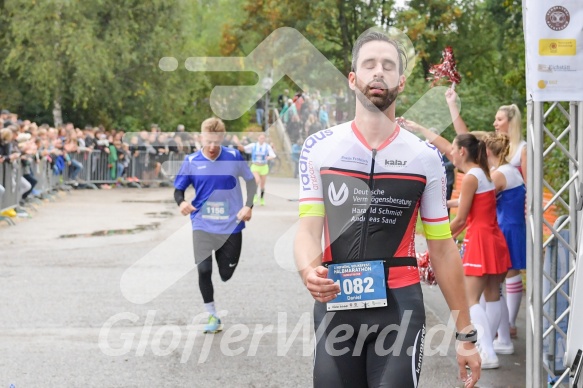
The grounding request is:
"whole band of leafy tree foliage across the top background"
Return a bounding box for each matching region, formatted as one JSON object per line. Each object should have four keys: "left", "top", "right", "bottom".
{"left": 0, "top": 0, "right": 526, "bottom": 135}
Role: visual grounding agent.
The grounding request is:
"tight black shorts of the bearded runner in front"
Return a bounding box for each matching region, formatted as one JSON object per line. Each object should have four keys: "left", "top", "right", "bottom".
{"left": 313, "top": 284, "right": 425, "bottom": 388}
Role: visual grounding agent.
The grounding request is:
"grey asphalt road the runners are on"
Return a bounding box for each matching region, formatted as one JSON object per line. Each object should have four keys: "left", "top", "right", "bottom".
{"left": 0, "top": 178, "right": 526, "bottom": 388}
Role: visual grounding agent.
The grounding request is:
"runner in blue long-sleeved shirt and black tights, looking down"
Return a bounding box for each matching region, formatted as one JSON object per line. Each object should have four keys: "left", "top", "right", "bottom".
{"left": 174, "top": 118, "right": 257, "bottom": 333}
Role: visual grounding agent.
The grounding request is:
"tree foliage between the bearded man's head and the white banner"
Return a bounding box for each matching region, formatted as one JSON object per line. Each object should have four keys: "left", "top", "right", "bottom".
{"left": 397, "top": 0, "right": 524, "bottom": 139}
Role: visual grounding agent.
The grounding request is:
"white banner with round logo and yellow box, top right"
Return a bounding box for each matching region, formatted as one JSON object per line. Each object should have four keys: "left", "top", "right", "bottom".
{"left": 522, "top": 0, "right": 583, "bottom": 101}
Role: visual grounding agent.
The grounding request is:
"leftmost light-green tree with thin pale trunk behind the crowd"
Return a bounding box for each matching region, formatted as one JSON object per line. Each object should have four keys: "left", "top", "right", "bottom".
{"left": 4, "top": 0, "right": 109, "bottom": 125}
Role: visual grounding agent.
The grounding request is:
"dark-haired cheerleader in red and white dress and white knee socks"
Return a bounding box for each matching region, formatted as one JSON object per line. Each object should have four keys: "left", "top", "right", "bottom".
{"left": 450, "top": 134, "right": 511, "bottom": 369}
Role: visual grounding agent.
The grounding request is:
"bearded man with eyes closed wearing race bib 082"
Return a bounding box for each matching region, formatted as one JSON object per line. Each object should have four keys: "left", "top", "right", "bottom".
{"left": 295, "top": 31, "right": 480, "bottom": 388}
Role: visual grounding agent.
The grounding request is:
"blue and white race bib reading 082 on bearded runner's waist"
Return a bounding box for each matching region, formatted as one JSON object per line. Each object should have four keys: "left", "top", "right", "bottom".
{"left": 326, "top": 260, "right": 387, "bottom": 311}
